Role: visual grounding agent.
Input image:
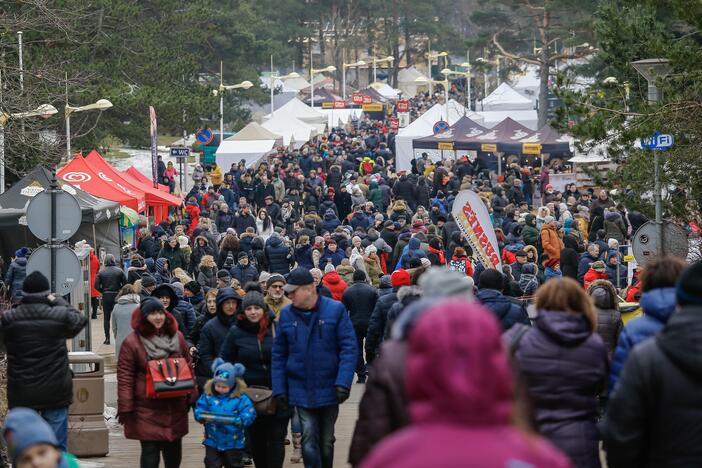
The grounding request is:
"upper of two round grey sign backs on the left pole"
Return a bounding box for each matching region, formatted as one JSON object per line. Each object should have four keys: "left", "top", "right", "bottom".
{"left": 27, "top": 190, "right": 83, "bottom": 242}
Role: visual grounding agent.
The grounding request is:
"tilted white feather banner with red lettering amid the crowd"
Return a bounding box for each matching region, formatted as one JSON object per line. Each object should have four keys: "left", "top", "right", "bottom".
{"left": 451, "top": 190, "right": 502, "bottom": 271}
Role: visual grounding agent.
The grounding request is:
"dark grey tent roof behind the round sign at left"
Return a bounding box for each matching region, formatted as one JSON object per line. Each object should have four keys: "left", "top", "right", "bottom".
{"left": 0, "top": 166, "right": 119, "bottom": 223}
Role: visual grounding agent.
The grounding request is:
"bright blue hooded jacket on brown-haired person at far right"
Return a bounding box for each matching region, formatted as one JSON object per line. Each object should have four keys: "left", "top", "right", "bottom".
{"left": 609, "top": 288, "right": 676, "bottom": 393}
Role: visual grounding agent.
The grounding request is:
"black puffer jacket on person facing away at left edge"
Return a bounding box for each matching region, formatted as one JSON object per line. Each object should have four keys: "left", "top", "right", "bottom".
{"left": 0, "top": 293, "right": 88, "bottom": 410}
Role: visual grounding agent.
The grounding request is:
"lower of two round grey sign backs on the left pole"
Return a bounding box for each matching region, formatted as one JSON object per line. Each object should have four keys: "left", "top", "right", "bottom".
{"left": 27, "top": 244, "right": 81, "bottom": 296}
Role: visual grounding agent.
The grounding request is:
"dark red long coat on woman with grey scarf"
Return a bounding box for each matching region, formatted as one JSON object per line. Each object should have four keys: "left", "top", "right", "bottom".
{"left": 117, "top": 307, "right": 198, "bottom": 442}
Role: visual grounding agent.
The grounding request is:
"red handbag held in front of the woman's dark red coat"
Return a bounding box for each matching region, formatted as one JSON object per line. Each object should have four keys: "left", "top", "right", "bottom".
{"left": 146, "top": 358, "right": 195, "bottom": 399}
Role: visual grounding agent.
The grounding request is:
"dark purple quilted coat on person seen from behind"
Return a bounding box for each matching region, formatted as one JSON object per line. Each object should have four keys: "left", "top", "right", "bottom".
{"left": 506, "top": 311, "right": 609, "bottom": 468}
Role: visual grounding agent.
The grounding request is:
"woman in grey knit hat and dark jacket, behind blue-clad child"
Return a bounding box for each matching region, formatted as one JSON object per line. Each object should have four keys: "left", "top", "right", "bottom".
{"left": 221, "top": 284, "right": 291, "bottom": 468}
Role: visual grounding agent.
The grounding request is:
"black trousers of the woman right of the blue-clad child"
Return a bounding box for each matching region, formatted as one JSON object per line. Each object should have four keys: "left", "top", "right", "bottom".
{"left": 248, "top": 416, "right": 288, "bottom": 468}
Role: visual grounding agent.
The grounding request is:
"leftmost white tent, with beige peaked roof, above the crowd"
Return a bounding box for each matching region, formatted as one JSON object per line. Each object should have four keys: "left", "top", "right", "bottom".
{"left": 215, "top": 122, "right": 283, "bottom": 167}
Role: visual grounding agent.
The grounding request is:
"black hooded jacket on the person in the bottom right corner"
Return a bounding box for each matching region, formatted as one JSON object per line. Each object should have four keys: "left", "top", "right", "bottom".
{"left": 600, "top": 306, "right": 702, "bottom": 468}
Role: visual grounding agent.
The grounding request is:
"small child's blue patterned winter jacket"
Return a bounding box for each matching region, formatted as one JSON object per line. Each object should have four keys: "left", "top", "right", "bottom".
{"left": 194, "top": 383, "right": 256, "bottom": 451}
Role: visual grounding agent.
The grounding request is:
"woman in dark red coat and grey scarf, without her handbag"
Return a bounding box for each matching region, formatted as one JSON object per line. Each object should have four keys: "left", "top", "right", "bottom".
{"left": 117, "top": 297, "right": 197, "bottom": 468}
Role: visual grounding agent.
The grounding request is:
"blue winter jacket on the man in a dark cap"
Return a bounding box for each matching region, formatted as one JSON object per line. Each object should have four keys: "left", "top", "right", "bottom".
{"left": 271, "top": 296, "right": 357, "bottom": 408}
